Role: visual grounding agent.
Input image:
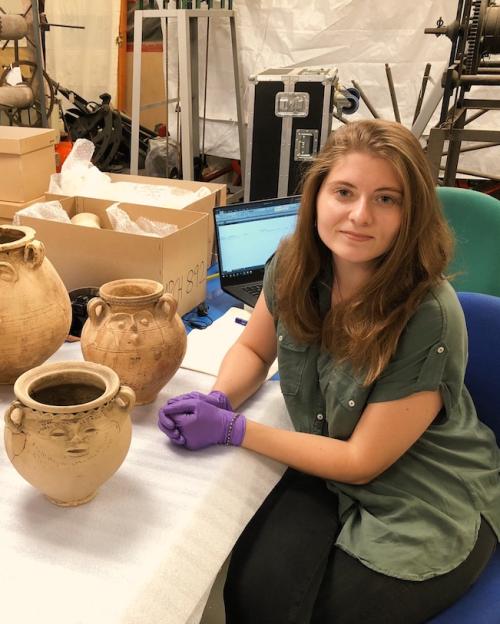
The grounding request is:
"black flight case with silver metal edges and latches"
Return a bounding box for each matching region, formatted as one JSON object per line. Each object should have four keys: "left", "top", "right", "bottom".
{"left": 244, "top": 67, "right": 345, "bottom": 201}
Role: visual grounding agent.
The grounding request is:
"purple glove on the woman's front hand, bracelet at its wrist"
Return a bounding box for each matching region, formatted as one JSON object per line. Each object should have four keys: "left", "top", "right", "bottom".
{"left": 158, "top": 398, "right": 246, "bottom": 451}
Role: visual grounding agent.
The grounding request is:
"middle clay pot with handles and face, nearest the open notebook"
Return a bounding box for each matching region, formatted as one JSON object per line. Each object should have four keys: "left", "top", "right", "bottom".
{"left": 81, "top": 279, "right": 187, "bottom": 405}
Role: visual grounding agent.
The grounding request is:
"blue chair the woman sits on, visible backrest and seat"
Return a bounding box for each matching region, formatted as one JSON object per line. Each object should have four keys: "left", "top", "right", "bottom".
{"left": 428, "top": 292, "right": 500, "bottom": 624}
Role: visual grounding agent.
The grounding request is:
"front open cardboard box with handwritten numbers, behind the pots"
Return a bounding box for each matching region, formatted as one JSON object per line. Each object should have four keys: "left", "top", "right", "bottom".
{"left": 17, "top": 197, "right": 208, "bottom": 315}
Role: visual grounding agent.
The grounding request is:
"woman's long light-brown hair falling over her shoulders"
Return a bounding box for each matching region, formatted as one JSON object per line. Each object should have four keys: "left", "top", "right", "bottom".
{"left": 275, "top": 120, "right": 453, "bottom": 384}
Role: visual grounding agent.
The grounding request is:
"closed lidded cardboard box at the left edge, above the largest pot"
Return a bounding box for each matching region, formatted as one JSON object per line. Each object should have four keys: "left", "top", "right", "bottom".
{"left": 0, "top": 126, "right": 56, "bottom": 202}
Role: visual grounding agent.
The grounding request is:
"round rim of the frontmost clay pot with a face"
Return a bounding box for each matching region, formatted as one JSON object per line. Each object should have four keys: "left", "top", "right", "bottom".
{"left": 14, "top": 360, "right": 120, "bottom": 414}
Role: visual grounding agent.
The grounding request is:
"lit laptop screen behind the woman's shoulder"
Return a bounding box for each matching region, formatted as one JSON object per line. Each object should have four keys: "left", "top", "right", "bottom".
{"left": 214, "top": 196, "right": 300, "bottom": 277}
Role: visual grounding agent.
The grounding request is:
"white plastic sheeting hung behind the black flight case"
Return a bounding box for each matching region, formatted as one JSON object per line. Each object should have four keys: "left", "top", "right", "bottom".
{"left": 161, "top": 0, "right": 500, "bottom": 174}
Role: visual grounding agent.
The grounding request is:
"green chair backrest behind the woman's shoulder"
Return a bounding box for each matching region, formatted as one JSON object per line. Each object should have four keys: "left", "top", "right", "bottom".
{"left": 437, "top": 186, "right": 500, "bottom": 297}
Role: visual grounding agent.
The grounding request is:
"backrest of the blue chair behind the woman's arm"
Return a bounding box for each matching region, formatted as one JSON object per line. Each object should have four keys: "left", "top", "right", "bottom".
{"left": 458, "top": 292, "right": 500, "bottom": 443}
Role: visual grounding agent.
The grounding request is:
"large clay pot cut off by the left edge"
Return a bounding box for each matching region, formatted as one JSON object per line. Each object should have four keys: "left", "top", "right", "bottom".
{"left": 0, "top": 225, "right": 71, "bottom": 383}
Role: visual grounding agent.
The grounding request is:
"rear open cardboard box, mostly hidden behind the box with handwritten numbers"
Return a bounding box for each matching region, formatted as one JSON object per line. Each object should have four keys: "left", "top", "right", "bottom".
{"left": 47, "top": 173, "right": 227, "bottom": 266}
